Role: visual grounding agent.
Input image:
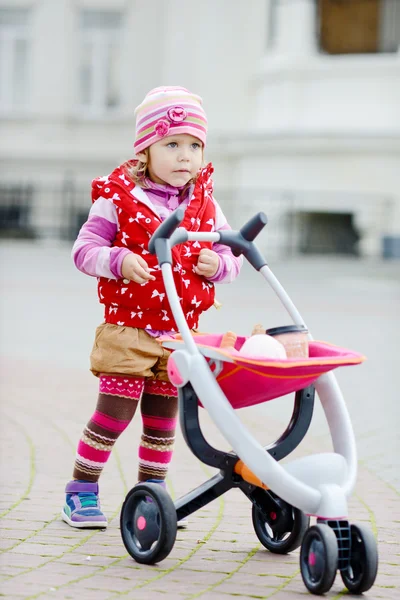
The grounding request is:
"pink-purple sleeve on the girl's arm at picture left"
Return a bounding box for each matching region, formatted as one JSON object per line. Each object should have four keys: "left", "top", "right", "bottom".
{"left": 72, "top": 197, "right": 130, "bottom": 279}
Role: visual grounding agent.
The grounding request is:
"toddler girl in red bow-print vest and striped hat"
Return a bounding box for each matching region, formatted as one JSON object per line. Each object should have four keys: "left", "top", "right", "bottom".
{"left": 62, "top": 87, "right": 241, "bottom": 528}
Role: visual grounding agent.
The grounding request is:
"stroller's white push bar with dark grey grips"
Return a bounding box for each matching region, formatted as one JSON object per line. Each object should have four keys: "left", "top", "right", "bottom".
{"left": 149, "top": 208, "right": 268, "bottom": 271}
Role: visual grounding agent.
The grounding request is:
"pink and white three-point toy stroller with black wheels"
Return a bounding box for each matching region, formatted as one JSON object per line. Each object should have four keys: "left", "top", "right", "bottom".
{"left": 120, "top": 208, "right": 378, "bottom": 594}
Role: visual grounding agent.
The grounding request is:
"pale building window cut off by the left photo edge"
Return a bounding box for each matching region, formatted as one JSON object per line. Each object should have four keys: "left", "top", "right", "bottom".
{"left": 0, "top": 8, "right": 30, "bottom": 111}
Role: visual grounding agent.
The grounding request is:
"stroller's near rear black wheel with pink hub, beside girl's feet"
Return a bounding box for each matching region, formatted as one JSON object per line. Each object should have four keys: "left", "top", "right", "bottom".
{"left": 120, "top": 483, "right": 177, "bottom": 565}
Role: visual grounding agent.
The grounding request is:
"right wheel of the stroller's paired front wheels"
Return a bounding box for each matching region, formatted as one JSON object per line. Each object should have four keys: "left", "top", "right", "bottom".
{"left": 340, "top": 525, "right": 378, "bottom": 594}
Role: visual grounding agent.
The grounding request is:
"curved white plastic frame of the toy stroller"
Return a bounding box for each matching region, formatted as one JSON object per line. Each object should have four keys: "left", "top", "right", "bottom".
{"left": 153, "top": 213, "right": 357, "bottom": 519}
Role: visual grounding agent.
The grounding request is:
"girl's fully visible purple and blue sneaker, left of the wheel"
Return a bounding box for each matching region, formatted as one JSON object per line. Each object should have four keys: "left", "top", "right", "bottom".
{"left": 61, "top": 479, "right": 108, "bottom": 529}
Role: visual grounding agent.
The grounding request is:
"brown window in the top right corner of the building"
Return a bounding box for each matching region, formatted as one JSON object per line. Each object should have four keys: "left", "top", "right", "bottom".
{"left": 318, "top": 0, "right": 400, "bottom": 54}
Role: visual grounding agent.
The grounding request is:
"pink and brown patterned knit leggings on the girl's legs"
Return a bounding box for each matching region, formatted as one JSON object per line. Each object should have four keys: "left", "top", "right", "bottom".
{"left": 73, "top": 375, "right": 178, "bottom": 481}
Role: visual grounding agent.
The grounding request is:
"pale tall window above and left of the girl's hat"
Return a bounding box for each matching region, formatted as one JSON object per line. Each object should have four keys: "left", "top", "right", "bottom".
{"left": 79, "top": 10, "right": 122, "bottom": 115}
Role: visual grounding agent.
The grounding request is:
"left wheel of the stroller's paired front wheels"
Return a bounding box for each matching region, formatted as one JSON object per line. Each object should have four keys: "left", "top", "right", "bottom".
{"left": 300, "top": 525, "right": 339, "bottom": 594}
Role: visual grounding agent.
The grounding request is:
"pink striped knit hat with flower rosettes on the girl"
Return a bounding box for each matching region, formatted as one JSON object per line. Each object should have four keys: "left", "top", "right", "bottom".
{"left": 134, "top": 86, "right": 207, "bottom": 153}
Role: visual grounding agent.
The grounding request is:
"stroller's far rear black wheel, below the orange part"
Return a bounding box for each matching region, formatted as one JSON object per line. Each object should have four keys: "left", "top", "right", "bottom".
{"left": 251, "top": 495, "right": 310, "bottom": 554}
